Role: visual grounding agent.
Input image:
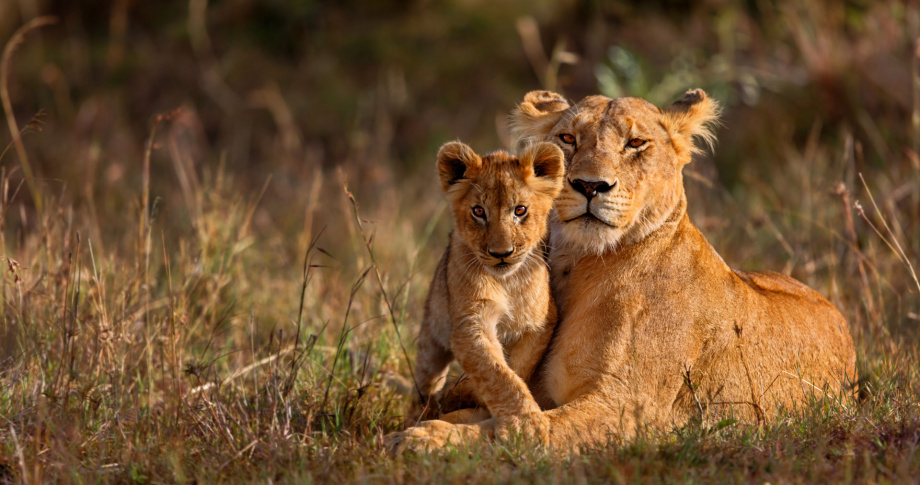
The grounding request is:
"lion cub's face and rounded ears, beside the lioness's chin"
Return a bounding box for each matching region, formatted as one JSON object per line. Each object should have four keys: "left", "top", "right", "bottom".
{"left": 438, "top": 142, "right": 564, "bottom": 276}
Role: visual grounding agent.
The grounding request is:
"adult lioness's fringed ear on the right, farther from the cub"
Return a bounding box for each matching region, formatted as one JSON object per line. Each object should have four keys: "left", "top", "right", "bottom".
{"left": 662, "top": 89, "right": 722, "bottom": 164}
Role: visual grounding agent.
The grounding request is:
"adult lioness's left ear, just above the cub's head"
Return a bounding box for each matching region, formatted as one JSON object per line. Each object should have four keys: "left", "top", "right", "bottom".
{"left": 511, "top": 91, "right": 570, "bottom": 149}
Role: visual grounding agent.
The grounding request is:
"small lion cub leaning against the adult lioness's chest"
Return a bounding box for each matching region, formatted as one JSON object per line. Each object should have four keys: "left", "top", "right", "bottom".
{"left": 415, "top": 142, "right": 564, "bottom": 429}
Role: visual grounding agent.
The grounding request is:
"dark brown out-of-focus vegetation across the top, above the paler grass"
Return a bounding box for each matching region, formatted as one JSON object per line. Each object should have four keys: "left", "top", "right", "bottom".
{"left": 0, "top": 0, "right": 920, "bottom": 195}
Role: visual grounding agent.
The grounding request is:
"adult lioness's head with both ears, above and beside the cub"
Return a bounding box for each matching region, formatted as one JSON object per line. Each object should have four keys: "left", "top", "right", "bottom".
{"left": 512, "top": 89, "right": 719, "bottom": 254}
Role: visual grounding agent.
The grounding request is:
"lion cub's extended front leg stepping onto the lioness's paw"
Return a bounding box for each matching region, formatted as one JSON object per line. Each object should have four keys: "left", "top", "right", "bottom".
{"left": 450, "top": 308, "right": 547, "bottom": 441}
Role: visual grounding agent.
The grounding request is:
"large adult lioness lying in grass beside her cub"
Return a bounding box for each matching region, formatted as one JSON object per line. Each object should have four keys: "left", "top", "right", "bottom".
{"left": 386, "top": 90, "right": 856, "bottom": 449}
